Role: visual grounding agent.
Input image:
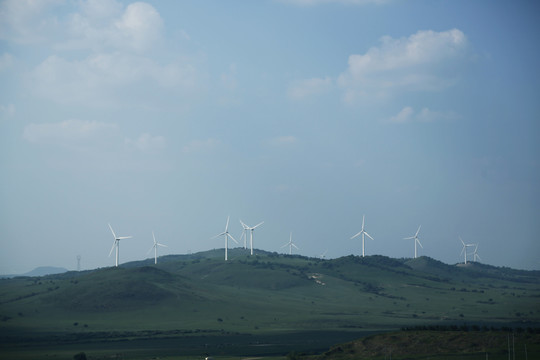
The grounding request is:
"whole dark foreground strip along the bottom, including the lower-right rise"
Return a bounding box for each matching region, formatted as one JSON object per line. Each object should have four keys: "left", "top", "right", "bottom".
{"left": 0, "top": 329, "right": 540, "bottom": 360}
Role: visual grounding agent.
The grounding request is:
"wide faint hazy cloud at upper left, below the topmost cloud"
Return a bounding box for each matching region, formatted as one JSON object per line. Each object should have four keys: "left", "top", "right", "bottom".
{"left": 27, "top": 53, "right": 200, "bottom": 105}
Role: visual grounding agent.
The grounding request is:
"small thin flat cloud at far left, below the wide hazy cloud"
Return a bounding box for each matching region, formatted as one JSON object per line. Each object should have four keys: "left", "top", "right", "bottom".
{"left": 23, "top": 119, "right": 116, "bottom": 145}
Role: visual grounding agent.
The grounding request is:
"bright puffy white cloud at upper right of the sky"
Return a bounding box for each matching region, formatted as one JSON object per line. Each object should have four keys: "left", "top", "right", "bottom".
{"left": 338, "top": 29, "right": 467, "bottom": 102}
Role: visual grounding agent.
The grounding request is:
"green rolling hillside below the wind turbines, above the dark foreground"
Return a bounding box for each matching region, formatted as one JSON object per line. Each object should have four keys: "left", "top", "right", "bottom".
{"left": 0, "top": 249, "right": 540, "bottom": 334}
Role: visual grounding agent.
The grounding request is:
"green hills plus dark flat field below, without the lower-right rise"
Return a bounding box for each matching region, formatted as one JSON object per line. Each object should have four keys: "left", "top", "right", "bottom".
{"left": 0, "top": 249, "right": 540, "bottom": 359}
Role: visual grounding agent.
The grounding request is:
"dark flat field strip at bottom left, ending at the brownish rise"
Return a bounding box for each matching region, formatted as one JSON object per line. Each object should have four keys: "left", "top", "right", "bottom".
{"left": 0, "top": 331, "right": 368, "bottom": 360}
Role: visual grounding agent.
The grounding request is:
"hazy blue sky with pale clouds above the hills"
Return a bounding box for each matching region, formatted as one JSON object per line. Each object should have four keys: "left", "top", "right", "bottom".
{"left": 0, "top": 0, "right": 540, "bottom": 274}
